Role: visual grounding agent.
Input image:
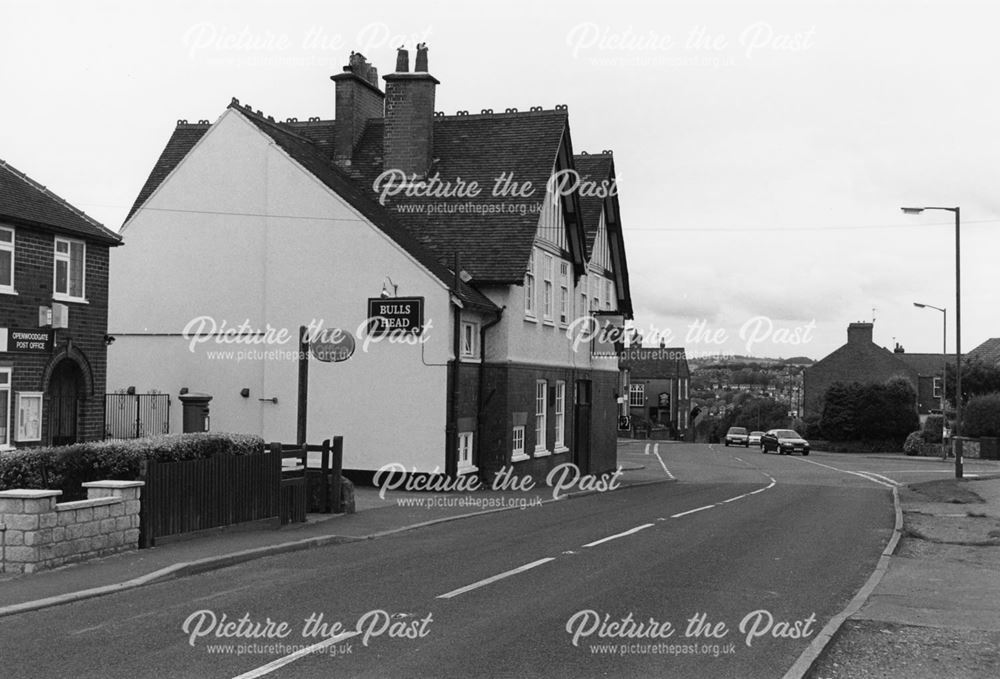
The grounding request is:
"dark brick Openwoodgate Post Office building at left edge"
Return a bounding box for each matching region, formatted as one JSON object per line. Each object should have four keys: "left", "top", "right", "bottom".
{"left": 0, "top": 160, "right": 121, "bottom": 454}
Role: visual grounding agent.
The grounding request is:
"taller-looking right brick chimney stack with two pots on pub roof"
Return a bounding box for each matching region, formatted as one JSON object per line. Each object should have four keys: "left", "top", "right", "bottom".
{"left": 382, "top": 43, "right": 439, "bottom": 178}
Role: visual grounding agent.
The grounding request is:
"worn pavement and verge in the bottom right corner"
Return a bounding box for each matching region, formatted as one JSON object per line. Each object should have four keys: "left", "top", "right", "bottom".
{"left": 806, "top": 476, "right": 1000, "bottom": 679}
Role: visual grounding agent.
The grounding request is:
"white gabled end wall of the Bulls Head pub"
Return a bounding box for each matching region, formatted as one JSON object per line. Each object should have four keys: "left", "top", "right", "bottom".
{"left": 108, "top": 110, "right": 452, "bottom": 471}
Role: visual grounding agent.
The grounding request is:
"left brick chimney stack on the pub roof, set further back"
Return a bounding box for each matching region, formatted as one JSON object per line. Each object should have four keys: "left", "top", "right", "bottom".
{"left": 330, "top": 52, "right": 385, "bottom": 167}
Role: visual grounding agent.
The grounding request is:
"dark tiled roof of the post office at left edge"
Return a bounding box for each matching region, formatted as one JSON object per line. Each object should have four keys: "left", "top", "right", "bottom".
{"left": 0, "top": 160, "right": 122, "bottom": 245}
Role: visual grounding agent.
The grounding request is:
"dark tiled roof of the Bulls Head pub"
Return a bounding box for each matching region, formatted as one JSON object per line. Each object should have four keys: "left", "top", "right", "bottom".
{"left": 123, "top": 100, "right": 631, "bottom": 317}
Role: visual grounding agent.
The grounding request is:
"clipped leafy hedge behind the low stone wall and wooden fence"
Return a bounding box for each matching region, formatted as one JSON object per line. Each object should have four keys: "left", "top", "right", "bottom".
{"left": 0, "top": 433, "right": 265, "bottom": 500}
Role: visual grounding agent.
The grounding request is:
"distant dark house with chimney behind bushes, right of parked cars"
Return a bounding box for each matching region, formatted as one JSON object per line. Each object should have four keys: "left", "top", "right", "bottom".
{"left": 803, "top": 323, "right": 954, "bottom": 418}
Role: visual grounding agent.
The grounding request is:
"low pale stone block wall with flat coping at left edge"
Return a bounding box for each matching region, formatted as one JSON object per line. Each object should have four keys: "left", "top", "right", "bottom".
{"left": 0, "top": 481, "right": 143, "bottom": 573}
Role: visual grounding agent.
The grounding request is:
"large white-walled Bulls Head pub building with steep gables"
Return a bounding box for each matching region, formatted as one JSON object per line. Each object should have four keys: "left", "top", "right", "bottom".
{"left": 109, "top": 49, "right": 632, "bottom": 484}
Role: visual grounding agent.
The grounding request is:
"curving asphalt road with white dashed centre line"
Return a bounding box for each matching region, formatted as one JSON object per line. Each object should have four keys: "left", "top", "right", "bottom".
{"left": 0, "top": 443, "right": 908, "bottom": 678}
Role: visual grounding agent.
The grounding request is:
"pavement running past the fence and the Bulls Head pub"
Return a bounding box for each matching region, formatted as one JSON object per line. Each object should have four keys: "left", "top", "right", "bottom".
{"left": 0, "top": 454, "right": 674, "bottom": 617}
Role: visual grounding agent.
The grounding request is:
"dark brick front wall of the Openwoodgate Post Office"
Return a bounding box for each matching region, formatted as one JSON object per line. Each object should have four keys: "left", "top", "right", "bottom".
{"left": 0, "top": 226, "right": 108, "bottom": 446}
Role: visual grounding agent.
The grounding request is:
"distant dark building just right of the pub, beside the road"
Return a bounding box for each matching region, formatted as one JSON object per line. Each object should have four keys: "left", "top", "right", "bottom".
{"left": 621, "top": 347, "right": 691, "bottom": 437}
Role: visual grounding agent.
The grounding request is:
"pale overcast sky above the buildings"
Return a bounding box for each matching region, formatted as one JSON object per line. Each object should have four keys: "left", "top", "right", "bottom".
{"left": 0, "top": 0, "right": 1000, "bottom": 358}
